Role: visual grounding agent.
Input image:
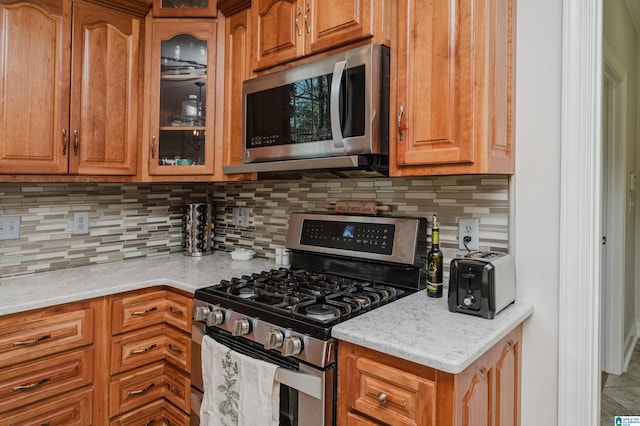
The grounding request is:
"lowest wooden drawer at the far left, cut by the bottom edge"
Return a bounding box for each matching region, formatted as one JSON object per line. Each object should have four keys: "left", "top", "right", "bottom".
{"left": 0, "top": 389, "right": 93, "bottom": 426}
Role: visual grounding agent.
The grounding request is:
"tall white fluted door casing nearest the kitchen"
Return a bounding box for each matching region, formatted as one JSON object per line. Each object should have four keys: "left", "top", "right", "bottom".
{"left": 557, "top": 0, "right": 603, "bottom": 426}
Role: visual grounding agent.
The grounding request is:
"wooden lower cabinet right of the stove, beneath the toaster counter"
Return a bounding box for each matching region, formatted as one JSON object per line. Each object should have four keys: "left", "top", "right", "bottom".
{"left": 338, "top": 326, "right": 522, "bottom": 426}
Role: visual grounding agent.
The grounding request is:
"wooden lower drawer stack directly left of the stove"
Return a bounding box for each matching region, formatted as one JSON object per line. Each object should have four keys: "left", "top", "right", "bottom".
{"left": 105, "top": 288, "right": 191, "bottom": 425}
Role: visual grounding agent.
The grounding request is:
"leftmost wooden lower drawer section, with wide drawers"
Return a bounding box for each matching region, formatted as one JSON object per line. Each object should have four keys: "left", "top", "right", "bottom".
{"left": 0, "top": 299, "right": 103, "bottom": 425}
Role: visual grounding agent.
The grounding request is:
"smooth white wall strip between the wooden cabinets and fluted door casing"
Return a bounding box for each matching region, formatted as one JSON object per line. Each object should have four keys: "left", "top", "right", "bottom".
{"left": 512, "top": 0, "right": 562, "bottom": 426}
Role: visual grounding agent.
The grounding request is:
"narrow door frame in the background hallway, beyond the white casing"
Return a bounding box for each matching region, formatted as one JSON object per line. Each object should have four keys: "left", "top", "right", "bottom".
{"left": 601, "top": 40, "right": 627, "bottom": 375}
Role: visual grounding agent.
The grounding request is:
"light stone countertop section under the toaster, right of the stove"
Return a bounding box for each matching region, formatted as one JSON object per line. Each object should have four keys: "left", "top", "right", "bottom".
{"left": 331, "top": 290, "right": 533, "bottom": 374}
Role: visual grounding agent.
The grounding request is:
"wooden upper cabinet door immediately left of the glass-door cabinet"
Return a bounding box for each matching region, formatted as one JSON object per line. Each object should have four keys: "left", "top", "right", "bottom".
{"left": 70, "top": 3, "right": 140, "bottom": 175}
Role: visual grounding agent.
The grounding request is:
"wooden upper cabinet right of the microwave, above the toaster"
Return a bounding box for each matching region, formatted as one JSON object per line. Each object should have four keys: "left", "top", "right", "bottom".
{"left": 390, "top": 0, "right": 515, "bottom": 176}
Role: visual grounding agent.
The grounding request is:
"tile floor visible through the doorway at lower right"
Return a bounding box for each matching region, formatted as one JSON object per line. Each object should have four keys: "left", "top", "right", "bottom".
{"left": 600, "top": 342, "right": 640, "bottom": 426}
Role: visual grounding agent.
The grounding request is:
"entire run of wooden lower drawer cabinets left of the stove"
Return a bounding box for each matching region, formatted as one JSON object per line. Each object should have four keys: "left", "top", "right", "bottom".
{"left": 0, "top": 287, "right": 192, "bottom": 426}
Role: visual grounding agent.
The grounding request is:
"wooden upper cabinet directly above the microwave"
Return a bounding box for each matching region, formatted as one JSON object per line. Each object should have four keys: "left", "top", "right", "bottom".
{"left": 252, "top": 0, "right": 388, "bottom": 70}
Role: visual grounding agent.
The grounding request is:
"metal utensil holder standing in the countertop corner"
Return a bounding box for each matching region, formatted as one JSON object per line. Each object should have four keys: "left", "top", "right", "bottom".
{"left": 182, "top": 203, "right": 213, "bottom": 256}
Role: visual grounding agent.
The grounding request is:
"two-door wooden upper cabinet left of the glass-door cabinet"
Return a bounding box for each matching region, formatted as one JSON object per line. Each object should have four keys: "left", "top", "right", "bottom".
{"left": 0, "top": 0, "right": 150, "bottom": 176}
